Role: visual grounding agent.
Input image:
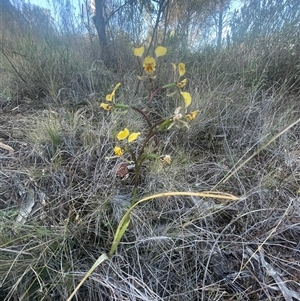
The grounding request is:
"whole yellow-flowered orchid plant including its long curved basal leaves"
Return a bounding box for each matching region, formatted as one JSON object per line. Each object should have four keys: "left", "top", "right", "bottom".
{"left": 67, "top": 46, "right": 238, "bottom": 301}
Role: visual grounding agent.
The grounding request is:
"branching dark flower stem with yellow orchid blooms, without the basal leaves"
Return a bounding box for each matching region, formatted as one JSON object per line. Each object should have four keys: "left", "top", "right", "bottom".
{"left": 100, "top": 46, "right": 199, "bottom": 203}
